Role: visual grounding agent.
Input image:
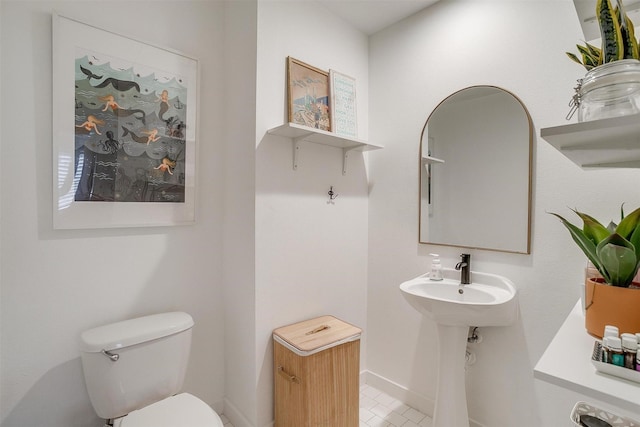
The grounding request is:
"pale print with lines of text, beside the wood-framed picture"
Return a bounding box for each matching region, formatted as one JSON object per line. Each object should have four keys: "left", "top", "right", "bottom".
{"left": 329, "top": 70, "right": 358, "bottom": 138}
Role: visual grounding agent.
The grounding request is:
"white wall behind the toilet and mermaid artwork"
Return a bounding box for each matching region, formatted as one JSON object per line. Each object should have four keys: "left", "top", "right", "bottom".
{"left": 0, "top": 0, "right": 224, "bottom": 427}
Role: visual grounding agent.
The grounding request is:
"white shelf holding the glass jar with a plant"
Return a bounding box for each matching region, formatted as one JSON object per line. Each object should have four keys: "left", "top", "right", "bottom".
{"left": 540, "top": 114, "right": 640, "bottom": 169}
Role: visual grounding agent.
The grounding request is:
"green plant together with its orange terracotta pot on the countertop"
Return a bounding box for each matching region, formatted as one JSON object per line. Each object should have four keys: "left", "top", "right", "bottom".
{"left": 551, "top": 207, "right": 640, "bottom": 338}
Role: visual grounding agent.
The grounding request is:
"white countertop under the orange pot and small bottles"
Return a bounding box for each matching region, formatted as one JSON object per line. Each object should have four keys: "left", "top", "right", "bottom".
{"left": 534, "top": 300, "right": 640, "bottom": 413}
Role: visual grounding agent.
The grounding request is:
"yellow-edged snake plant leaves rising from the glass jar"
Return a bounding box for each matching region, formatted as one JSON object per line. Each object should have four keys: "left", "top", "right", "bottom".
{"left": 566, "top": 0, "right": 640, "bottom": 71}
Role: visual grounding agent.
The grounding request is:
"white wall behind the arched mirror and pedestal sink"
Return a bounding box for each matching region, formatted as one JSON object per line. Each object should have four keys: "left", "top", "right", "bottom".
{"left": 367, "top": 0, "right": 640, "bottom": 427}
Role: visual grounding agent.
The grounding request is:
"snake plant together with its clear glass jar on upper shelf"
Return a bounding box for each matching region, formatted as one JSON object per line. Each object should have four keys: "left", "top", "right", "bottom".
{"left": 566, "top": 0, "right": 640, "bottom": 122}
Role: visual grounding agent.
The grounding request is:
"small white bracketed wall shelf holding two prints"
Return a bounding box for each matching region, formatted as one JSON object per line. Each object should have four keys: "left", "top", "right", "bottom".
{"left": 267, "top": 123, "right": 383, "bottom": 175}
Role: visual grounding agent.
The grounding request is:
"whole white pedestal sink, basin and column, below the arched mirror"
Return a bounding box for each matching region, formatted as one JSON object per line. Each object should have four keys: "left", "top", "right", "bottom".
{"left": 400, "top": 268, "right": 518, "bottom": 427}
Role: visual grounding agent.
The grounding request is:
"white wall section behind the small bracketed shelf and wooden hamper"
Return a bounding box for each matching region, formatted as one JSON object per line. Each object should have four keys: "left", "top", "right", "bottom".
{"left": 256, "top": 1, "right": 369, "bottom": 426}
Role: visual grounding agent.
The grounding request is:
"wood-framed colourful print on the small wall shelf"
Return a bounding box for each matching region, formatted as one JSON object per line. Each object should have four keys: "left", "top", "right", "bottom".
{"left": 287, "top": 56, "right": 332, "bottom": 132}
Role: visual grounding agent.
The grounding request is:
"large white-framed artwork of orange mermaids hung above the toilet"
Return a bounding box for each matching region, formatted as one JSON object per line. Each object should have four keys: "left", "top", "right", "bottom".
{"left": 53, "top": 14, "right": 198, "bottom": 229}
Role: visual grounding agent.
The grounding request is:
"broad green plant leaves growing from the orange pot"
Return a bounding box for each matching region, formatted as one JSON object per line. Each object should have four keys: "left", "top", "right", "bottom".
{"left": 551, "top": 207, "right": 640, "bottom": 288}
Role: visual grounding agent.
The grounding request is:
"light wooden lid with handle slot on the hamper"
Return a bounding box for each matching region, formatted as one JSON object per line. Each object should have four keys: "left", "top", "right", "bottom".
{"left": 273, "top": 316, "right": 362, "bottom": 356}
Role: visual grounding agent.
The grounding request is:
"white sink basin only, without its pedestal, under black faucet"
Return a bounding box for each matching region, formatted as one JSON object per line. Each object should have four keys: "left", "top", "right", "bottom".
{"left": 400, "top": 268, "right": 518, "bottom": 326}
